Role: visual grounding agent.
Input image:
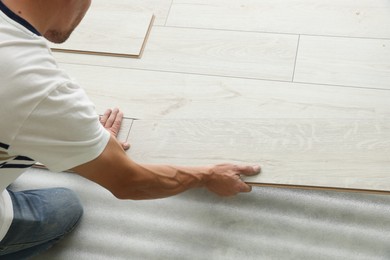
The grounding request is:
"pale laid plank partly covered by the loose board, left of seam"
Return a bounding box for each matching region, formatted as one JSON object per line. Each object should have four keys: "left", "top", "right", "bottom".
{"left": 55, "top": 27, "right": 298, "bottom": 81}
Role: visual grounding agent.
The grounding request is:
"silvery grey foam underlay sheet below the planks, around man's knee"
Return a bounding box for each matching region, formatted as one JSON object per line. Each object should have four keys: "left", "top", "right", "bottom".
{"left": 11, "top": 169, "right": 390, "bottom": 260}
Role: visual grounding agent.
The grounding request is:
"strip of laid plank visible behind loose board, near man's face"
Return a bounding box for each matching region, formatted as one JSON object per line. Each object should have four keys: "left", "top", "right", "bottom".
{"left": 92, "top": 0, "right": 172, "bottom": 26}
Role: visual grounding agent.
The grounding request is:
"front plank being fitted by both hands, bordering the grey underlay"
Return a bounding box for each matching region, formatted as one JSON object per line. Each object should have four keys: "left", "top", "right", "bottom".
{"left": 128, "top": 119, "right": 390, "bottom": 192}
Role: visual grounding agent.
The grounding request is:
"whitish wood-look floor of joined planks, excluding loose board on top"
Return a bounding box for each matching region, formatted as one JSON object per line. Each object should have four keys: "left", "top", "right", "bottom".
{"left": 54, "top": 0, "right": 390, "bottom": 191}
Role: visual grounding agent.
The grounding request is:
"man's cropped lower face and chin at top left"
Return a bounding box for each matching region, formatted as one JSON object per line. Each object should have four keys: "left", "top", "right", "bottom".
{"left": 2, "top": 0, "right": 91, "bottom": 43}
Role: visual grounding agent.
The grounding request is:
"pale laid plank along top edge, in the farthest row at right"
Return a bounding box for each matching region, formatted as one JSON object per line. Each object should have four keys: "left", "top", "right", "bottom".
{"left": 167, "top": 0, "right": 390, "bottom": 38}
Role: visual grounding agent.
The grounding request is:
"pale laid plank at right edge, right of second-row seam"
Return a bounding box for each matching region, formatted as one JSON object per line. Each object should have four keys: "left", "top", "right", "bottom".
{"left": 294, "top": 36, "right": 390, "bottom": 89}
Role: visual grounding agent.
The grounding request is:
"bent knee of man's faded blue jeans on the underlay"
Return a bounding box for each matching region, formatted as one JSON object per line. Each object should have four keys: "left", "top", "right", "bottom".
{"left": 0, "top": 188, "right": 83, "bottom": 260}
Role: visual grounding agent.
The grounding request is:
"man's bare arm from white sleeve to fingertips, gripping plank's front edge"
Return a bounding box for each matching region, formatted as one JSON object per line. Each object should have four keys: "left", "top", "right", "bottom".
{"left": 73, "top": 134, "right": 260, "bottom": 199}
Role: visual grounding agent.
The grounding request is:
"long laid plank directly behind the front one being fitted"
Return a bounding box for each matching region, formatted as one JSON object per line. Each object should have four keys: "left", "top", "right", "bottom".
{"left": 60, "top": 63, "right": 390, "bottom": 119}
